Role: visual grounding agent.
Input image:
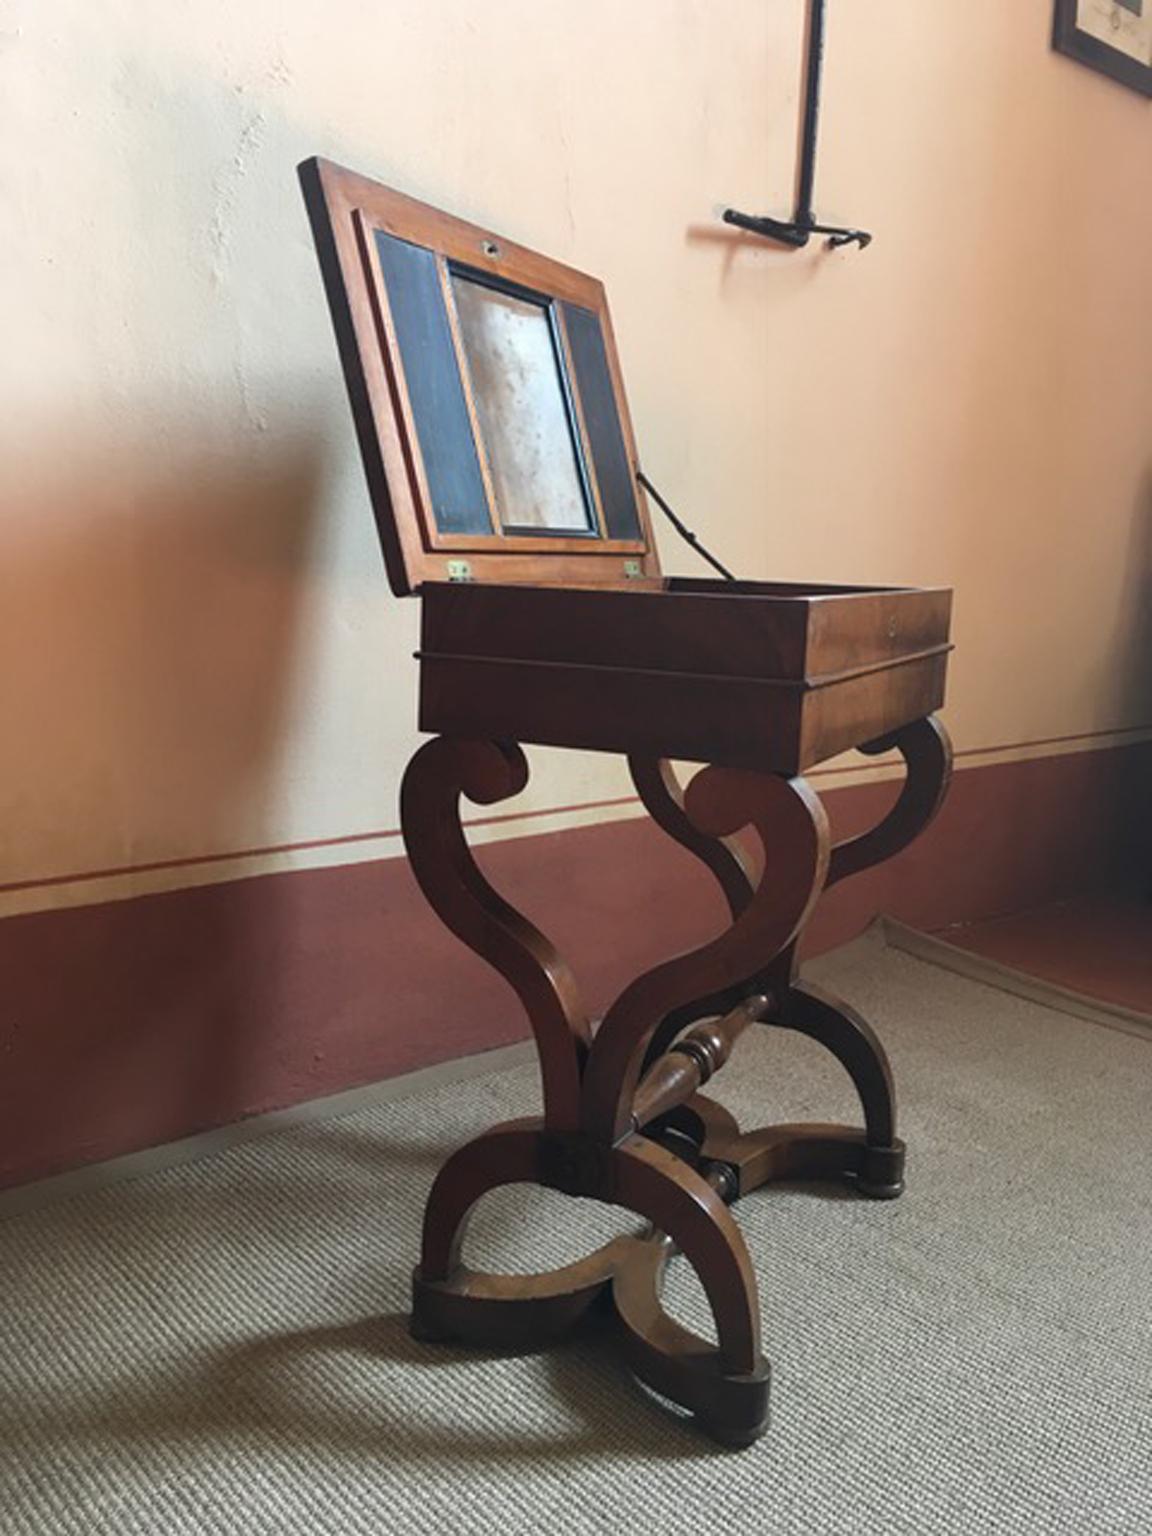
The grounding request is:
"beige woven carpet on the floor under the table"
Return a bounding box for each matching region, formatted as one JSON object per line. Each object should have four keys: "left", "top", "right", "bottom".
{"left": 0, "top": 943, "right": 1152, "bottom": 1536}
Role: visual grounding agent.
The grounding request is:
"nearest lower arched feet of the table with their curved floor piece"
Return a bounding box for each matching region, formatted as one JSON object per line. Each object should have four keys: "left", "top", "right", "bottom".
{"left": 412, "top": 1120, "right": 770, "bottom": 1445}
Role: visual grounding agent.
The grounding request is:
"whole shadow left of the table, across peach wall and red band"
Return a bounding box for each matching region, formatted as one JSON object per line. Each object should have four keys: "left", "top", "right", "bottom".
{"left": 0, "top": 412, "right": 333, "bottom": 1167}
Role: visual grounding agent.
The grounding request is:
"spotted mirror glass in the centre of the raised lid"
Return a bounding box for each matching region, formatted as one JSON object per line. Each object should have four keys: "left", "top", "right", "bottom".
{"left": 452, "top": 272, "right": 598, "bottom": 536}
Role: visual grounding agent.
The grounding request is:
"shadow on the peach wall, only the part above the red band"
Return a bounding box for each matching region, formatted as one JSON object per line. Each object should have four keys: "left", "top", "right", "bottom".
{"left": 0, "top": 419, "right": 321, "bottom": 885}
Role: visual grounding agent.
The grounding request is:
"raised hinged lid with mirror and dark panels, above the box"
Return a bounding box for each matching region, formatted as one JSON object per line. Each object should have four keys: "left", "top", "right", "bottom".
{"left": 300, "top": 160, "right": 659, "bottom": 594}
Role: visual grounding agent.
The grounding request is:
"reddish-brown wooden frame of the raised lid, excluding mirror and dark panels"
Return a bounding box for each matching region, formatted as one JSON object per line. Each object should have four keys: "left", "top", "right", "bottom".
{"left": 300, "top": 160, "right": 659, "bottom": 594}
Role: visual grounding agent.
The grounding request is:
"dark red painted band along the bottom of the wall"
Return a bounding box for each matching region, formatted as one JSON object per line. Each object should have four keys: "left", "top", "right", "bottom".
{"left": 0, "top": 742, "right": 1152, "bottom": 1187}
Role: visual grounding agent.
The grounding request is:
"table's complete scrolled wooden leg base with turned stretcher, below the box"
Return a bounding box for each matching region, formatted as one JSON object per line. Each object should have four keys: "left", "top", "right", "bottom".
{"left": 402, "top": 720, "right": 949, "bottom": 1445}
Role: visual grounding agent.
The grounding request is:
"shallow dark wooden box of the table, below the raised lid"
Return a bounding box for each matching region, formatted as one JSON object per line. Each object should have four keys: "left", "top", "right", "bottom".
{"left": 419, "top": 578, "right": 951, "bottom": 774}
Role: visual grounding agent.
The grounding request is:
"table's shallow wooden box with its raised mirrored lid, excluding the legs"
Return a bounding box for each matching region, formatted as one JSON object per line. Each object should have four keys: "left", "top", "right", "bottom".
{"left": 301, "top": 161, "right": 951, "bottom": 774}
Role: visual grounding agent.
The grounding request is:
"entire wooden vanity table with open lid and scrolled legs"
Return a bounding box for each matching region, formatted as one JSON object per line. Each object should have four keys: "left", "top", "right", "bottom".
{"left": 301, "top": 160, "right": 951, "bottom": 1445}
